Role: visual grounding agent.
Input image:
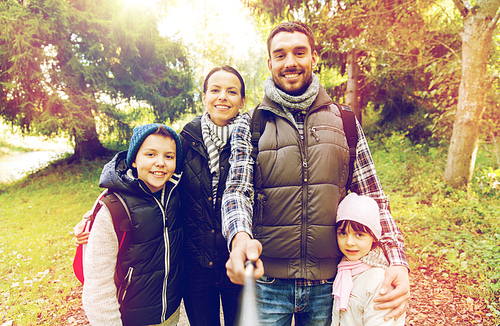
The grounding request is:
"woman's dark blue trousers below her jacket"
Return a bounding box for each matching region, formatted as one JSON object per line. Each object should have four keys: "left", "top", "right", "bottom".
{"left": 183, "top": 264, "right": 242, "bottom": 326}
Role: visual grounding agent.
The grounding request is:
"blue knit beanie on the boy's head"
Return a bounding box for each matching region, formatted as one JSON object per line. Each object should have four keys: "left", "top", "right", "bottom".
{"left": 127, "top": 123, "right": 182, "bottom": 173}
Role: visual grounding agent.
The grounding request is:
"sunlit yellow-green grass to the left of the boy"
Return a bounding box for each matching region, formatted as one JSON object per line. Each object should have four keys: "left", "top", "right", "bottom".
{"left": 0, "top": 157, "right": 104, "bottom": 325}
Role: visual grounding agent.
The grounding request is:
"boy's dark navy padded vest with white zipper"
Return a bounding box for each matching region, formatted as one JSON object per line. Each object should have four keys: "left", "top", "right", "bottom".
{"left": 100, "top": 152, "right": 183, "bottom": 326}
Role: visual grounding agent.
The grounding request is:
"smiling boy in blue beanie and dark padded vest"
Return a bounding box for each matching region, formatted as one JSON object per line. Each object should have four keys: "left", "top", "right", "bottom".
{"left": 83, "top": 124, "right": 182, "bottom": 326}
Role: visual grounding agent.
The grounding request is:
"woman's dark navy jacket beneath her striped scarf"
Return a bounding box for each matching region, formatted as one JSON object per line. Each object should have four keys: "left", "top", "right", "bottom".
{"left": 179, "top": 116, "right": 231, "bottom": 268}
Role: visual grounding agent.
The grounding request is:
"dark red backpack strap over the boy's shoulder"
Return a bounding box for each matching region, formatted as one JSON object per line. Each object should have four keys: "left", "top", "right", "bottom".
{"left": 100, "top": 191, "right": 132, "bottom": 288}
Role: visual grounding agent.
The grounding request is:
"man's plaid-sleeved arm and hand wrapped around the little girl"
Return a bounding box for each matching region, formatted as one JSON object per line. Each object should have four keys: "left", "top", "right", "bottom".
{"left": 350, "top": 119, "right": 410, "bottom": 320}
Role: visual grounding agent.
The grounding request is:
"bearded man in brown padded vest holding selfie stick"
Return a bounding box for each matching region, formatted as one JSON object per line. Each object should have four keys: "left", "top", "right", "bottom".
{"left": 222, "top": 22, "right": 410, "bottom": 325}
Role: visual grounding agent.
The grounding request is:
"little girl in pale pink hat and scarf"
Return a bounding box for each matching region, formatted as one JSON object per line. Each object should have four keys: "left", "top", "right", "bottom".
{"left": 332, "top": 193, "right": 405, "bottom": 326}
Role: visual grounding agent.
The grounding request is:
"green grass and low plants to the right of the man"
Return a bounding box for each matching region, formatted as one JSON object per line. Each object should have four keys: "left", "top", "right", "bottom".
{"left": 370, "top": 133, "right": 500, "bottom": 320}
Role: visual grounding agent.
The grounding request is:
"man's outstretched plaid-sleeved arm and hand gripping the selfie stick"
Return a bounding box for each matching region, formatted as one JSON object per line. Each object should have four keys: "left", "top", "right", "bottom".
{"left": 222, "top": 114, "right": 264, "bottom": 284}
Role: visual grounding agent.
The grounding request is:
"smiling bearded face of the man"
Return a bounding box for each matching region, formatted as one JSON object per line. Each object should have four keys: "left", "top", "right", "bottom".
{"left": 267, "top": 32, "right": 318, "bottom": 96}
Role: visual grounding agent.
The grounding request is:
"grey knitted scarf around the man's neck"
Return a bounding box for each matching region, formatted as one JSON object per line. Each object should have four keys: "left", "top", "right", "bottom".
{"left": 264, "top": 74, "right": 319, "bottom": 114}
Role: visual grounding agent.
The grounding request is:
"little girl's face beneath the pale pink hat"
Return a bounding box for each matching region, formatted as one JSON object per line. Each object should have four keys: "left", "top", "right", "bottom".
{"left": 337, "top": 225, "right": 374, "bottom": 260}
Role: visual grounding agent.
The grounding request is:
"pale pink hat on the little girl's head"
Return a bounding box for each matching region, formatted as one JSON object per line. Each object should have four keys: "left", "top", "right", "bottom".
{"left": 337, "top": 192, "right": 382, "bottom": 240}
